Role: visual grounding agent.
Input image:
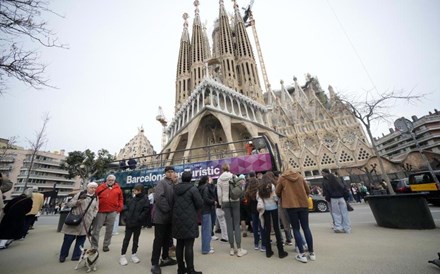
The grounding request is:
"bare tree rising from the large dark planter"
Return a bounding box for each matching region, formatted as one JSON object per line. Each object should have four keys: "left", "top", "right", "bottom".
{"left": 338, "top": 91, "right": 424, "bottom": 194}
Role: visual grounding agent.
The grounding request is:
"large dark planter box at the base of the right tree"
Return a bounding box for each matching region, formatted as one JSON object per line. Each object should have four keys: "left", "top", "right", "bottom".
{"left": 365, "top": 193, "right": 435, "bottom": 229}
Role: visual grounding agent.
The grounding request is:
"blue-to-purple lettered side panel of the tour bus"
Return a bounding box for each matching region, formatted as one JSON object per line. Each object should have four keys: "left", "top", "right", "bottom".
{"left": 114, "top": 153, "right": 272, "bottom": 188}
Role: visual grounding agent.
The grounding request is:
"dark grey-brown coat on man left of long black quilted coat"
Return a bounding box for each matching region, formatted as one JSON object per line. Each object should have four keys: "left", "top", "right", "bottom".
{"left": 153, "top": 177, "right": 174, "bottom": 224}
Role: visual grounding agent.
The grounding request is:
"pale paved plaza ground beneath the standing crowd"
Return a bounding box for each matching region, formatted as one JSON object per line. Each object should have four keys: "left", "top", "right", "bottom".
{"left": 0, "top": 204, "right": 440, "bottom": 274}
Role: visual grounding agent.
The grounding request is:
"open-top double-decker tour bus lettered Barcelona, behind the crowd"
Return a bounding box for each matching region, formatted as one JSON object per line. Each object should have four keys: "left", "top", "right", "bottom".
{"left": 108, "top": 136, "right": 282, "bottom": 195}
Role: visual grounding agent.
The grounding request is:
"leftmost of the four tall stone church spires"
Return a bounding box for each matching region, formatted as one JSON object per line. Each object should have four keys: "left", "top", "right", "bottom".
{"left": 174, "top": 12, "right": 191, "bottom": 112}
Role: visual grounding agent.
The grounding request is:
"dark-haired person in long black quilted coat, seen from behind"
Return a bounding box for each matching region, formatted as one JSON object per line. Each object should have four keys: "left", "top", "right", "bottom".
{"left": 172, "top": 171, "right": 203, "bottom": 274}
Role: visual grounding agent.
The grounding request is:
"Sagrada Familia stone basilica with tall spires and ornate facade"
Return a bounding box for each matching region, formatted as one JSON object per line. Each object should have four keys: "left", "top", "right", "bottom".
{"left": 118, "top": 1, "right": 384, "bottom": 179}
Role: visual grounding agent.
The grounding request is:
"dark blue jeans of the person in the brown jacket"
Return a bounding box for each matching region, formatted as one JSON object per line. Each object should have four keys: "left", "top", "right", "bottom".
{"left": 286, "top": 208, "right": 313, "bottom": 253}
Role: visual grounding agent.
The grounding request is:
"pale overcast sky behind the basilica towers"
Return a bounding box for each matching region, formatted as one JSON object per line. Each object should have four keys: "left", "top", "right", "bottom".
{"left": 0, "top": 0, "right": 440, "bottom": 156}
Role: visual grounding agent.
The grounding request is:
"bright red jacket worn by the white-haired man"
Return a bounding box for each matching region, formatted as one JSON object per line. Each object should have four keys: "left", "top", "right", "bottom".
{"left": 95, "top": 183, "right": 124, "bottom": 213}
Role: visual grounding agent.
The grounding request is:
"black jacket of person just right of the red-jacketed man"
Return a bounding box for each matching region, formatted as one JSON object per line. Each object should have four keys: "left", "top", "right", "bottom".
{"left": 123, "top": 193, "right": 150, "bottom": 227}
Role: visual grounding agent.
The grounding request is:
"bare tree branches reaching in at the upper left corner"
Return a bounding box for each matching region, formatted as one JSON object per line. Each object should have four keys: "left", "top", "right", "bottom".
{"left": 0, "top": 0, "right": 66, "bottom": 95}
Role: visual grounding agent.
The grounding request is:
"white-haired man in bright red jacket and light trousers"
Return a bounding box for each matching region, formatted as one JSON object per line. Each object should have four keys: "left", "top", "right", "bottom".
{"left": 92, "top": 175, "right": 124, "bottom": 252}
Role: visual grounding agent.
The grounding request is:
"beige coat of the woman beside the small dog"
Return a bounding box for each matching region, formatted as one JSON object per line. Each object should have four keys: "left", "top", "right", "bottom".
{"left": 61, "top": 191, "right": 99, "bottom": 236}
